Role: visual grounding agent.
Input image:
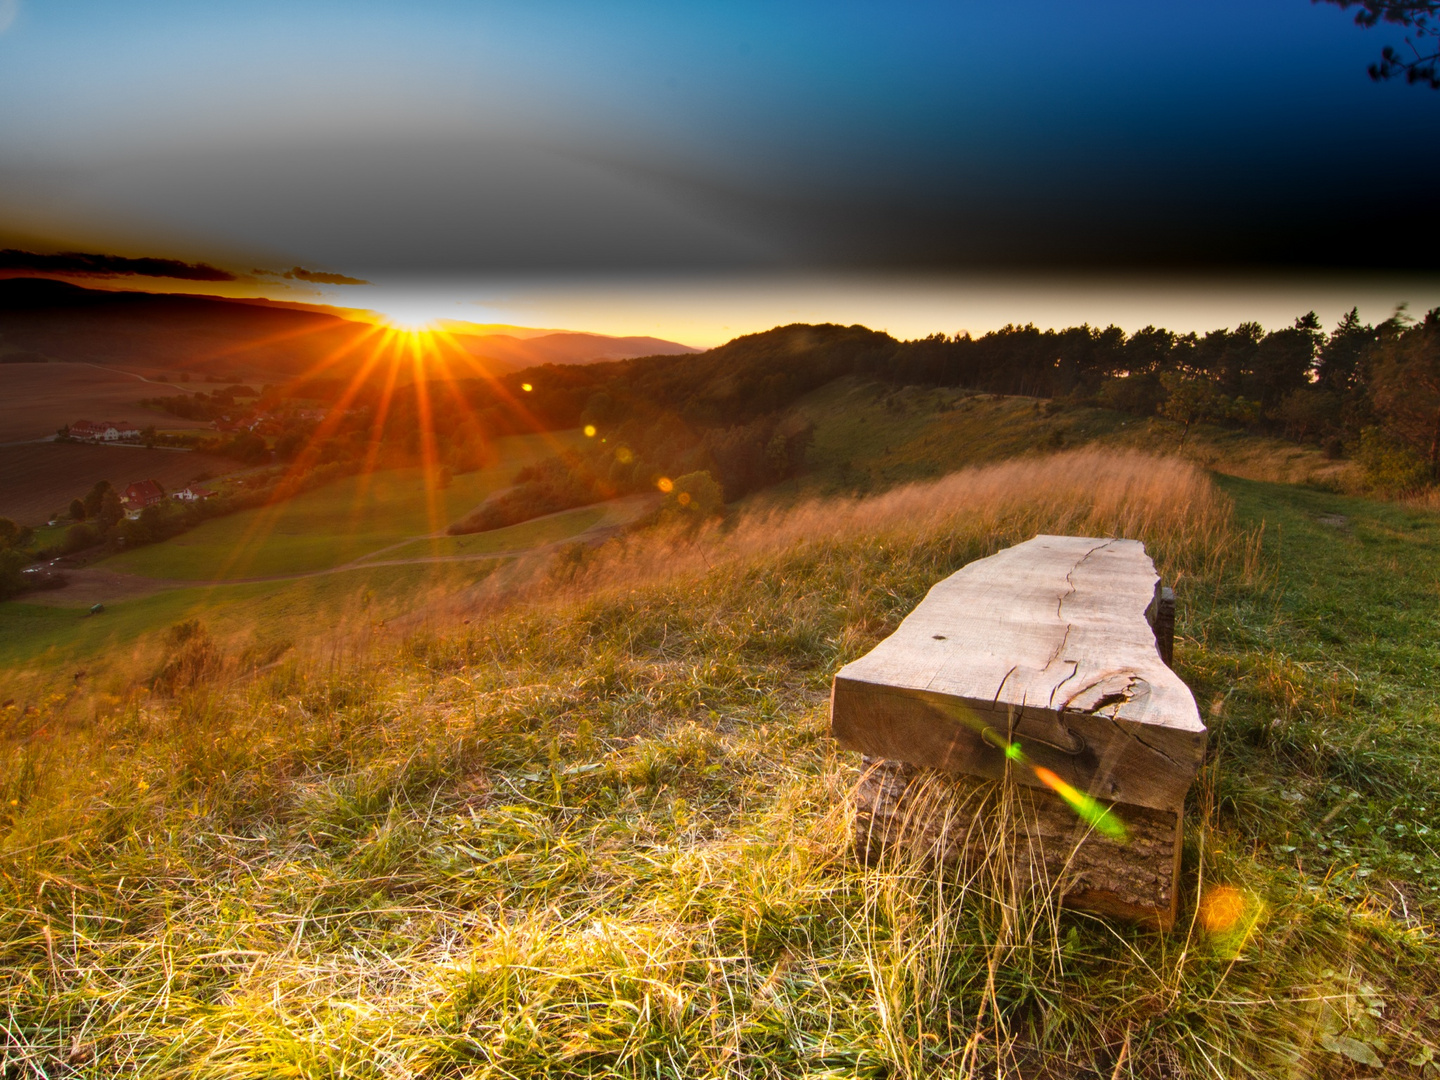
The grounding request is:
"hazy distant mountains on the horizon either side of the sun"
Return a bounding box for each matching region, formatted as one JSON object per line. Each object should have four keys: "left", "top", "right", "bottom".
{"left": 0, "top": 278, "right": 700, "bottom": 382}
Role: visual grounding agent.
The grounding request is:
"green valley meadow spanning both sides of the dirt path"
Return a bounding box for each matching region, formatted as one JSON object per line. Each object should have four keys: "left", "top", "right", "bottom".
{"left": 0, "top": 432, "right": 604, "bottom": 703}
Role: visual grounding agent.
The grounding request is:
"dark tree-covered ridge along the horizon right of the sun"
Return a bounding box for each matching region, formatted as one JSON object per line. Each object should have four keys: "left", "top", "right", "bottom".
{"left": 480, "top": 310, "right": 1440, "bottom": 498}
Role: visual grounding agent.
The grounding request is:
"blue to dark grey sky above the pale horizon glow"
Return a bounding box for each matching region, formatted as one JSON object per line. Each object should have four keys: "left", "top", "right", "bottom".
{"left": 0, "top": 0, "right": 1440, "bottom": 338}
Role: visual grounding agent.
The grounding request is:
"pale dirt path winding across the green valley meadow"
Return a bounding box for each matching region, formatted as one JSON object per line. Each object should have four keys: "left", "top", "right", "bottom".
{"left": 19, "top": 495, "right": 655, "bottom": 608}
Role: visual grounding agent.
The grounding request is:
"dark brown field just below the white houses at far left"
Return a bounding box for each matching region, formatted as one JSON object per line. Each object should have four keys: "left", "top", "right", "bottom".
{"left": 0, "top": 440, "right": 240, "bottom": 526}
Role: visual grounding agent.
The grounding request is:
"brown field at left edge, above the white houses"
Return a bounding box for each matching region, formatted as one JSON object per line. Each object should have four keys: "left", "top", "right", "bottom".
{"left": 0, "top": 363, "right": 215, "bottom": 444}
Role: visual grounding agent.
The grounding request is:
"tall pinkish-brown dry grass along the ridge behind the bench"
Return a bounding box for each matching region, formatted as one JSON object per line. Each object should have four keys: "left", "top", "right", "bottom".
{"left": 423, "top": 448, "right": 1260, "bottom": 624}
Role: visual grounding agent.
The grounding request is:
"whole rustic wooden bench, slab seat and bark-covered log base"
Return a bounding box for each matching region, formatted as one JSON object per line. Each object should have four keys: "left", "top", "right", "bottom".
{"left": 831, "top": 536, "right": 1205, "bottom": 927}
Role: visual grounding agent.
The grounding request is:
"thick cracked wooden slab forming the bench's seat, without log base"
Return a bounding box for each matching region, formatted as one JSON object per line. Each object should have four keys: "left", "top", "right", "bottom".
{"left": 831, "top": 536, "right": 1205, "bottom": 811}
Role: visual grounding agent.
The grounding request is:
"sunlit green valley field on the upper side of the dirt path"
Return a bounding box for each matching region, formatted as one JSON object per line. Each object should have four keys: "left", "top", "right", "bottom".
{"left": 98, "top": 432, "right": 577, "bottom": 580}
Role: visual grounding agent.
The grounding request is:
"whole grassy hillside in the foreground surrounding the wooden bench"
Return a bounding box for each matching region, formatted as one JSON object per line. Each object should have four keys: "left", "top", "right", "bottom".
{"left": 0, "top": 446, "right": 1440, "bottom": 1077}
